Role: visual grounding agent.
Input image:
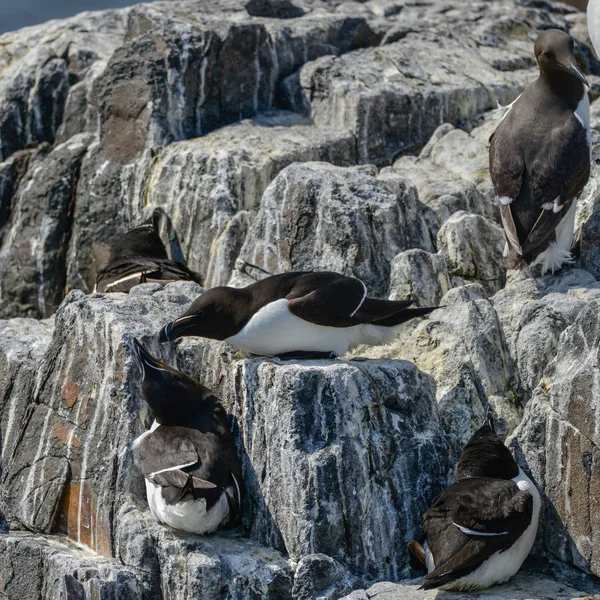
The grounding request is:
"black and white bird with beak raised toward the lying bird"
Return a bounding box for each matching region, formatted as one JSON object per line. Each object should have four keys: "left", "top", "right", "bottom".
{"left": 130, "top": 339, "right": 242, "bottom": 534}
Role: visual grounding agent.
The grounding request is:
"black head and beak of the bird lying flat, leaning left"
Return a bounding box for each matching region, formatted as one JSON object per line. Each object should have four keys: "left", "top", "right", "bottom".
{"left": 159, "top": 287, "right": 248, "bottom": 342}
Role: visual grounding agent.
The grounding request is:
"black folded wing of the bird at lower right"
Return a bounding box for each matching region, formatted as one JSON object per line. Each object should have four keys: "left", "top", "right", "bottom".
{"left": 423, "top": 477, "right": 533, "bottom": 589}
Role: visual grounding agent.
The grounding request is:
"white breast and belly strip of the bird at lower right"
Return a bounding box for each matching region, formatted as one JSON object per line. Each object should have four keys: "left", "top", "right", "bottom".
{"left": 441, "top": 469, "right": 542, "bottom": 590}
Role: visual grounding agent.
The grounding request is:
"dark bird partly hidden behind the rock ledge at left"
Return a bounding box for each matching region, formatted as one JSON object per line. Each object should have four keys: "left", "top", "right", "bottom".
{"left": 94, "top": 208, "right": 201, "bottom": 293}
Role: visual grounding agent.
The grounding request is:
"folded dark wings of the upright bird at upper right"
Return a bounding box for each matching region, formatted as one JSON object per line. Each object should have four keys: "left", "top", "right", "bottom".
{"left": 490, "top": 105, "right": 590, "bottom": 257}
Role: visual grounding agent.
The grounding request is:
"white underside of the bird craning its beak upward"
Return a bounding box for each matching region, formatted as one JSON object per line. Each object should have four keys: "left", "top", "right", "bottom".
{"left": 146, "top": 479, "right": 233, "bottom": 535}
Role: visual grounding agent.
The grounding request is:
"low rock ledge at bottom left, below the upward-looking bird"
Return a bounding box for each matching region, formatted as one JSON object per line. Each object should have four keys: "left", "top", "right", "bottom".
{"left": 0, "top": 524, "right": 292, "bottom": 600}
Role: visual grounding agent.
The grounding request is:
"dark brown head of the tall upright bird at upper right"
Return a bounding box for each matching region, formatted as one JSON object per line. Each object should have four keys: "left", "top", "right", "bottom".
{"left": 534, "top": 29, "right": 590, "bottom": 87}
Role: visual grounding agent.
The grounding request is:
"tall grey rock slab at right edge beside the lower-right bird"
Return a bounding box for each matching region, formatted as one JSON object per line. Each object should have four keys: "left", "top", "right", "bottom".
{"left": 513, "top": 300, "right": 600, "bottom": 575}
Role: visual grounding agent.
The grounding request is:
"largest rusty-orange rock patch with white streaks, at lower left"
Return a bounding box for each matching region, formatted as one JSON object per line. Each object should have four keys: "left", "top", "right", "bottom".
{"left": 52, "top": 482, "right": 112, "bottom": 558}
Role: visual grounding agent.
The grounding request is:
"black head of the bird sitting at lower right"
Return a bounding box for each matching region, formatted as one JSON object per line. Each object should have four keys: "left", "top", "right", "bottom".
{"left": 456, "top": 413, "right": 519, "bottom": 480}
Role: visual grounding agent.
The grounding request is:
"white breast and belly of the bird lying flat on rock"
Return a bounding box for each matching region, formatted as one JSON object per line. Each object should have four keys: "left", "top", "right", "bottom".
{"left": 227, "top": 298, "right": 396, "bottom": 356}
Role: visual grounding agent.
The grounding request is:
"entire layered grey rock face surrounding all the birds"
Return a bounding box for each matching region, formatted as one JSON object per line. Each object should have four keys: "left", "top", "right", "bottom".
{"left": 0, "top": 0, "right": 600, "bottom": 600}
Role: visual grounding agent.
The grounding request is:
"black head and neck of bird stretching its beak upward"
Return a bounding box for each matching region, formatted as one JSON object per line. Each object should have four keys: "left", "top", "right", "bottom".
{"left": 127, "top": 338, "right": 216, "bottom": 427}
